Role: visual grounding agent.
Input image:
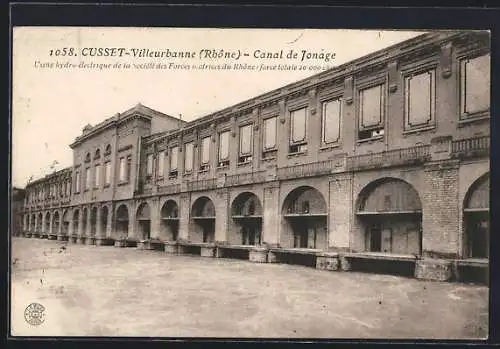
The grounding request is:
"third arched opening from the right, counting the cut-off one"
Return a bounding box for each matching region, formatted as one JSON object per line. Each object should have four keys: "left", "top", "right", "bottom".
{"left": 280, "top": 186, "right": 328, "bottom": 249}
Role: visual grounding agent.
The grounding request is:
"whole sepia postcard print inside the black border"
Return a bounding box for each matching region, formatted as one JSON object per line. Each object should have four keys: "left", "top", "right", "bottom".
{"left": 9, "top": 26, "right": 491, "bottom": 340}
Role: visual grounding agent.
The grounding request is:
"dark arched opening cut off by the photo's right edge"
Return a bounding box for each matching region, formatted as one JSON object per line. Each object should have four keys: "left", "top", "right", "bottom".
{"left": 464, "top": 173, "right": 490, "bottom": 258}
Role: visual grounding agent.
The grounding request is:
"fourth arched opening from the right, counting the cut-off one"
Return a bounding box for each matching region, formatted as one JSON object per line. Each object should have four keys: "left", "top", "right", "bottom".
{"left": 229, "top": 192, "right": 262, "bottom": 245}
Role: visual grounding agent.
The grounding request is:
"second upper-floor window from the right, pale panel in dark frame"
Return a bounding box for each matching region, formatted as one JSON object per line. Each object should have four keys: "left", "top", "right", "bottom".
{"left": 404, "top": 69, "right": 436, "bottom": 130}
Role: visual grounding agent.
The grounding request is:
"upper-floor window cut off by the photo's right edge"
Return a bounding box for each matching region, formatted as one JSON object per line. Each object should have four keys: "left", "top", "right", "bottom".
{"left": 460, "top": 54, "right": 491, "bottom": 119}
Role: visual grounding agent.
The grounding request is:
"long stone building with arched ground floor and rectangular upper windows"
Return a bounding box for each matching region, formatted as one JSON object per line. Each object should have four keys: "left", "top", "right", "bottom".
{"left": 17, "top": 32, "right": 490, "bottom": 279}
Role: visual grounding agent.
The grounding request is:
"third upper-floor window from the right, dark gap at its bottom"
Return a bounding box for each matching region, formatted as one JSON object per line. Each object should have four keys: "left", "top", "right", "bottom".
{"left": 358, "top": 84, "right": 385, "bottom": 140}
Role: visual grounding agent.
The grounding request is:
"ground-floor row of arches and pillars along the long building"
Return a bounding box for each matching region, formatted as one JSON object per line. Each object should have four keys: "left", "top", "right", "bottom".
{"left": 19, "top": 166, "right": 489, "bottom": 282}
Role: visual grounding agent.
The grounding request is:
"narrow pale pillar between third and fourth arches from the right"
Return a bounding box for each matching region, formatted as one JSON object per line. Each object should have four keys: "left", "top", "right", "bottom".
{"left": 262, "top": 182, "right": 281, "bottom": 247}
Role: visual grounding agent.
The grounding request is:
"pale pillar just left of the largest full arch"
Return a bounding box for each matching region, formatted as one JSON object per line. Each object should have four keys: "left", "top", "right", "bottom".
{"left": 328, "top": 174, "right": 355, "bottom": 251}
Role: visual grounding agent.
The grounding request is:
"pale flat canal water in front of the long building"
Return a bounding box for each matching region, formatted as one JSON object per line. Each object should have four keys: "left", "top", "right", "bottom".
{"left": 11, "top": 238, "right": 488, "bottom": 339}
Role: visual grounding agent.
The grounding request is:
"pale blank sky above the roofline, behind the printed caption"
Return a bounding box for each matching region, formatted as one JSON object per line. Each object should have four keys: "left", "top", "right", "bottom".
{"left": 12, "top": 27, "right": 428, "bottom": 187}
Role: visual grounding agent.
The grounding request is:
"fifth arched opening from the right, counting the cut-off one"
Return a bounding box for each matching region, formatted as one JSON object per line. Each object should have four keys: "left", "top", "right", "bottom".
{"left": 190, "top": 196, "right": 215, "bottom": 242}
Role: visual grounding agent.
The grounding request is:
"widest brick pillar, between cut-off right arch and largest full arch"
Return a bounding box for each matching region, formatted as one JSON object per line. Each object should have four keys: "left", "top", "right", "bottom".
{"left": 422, "top": 160, "right": 460, "bottom": 258}
